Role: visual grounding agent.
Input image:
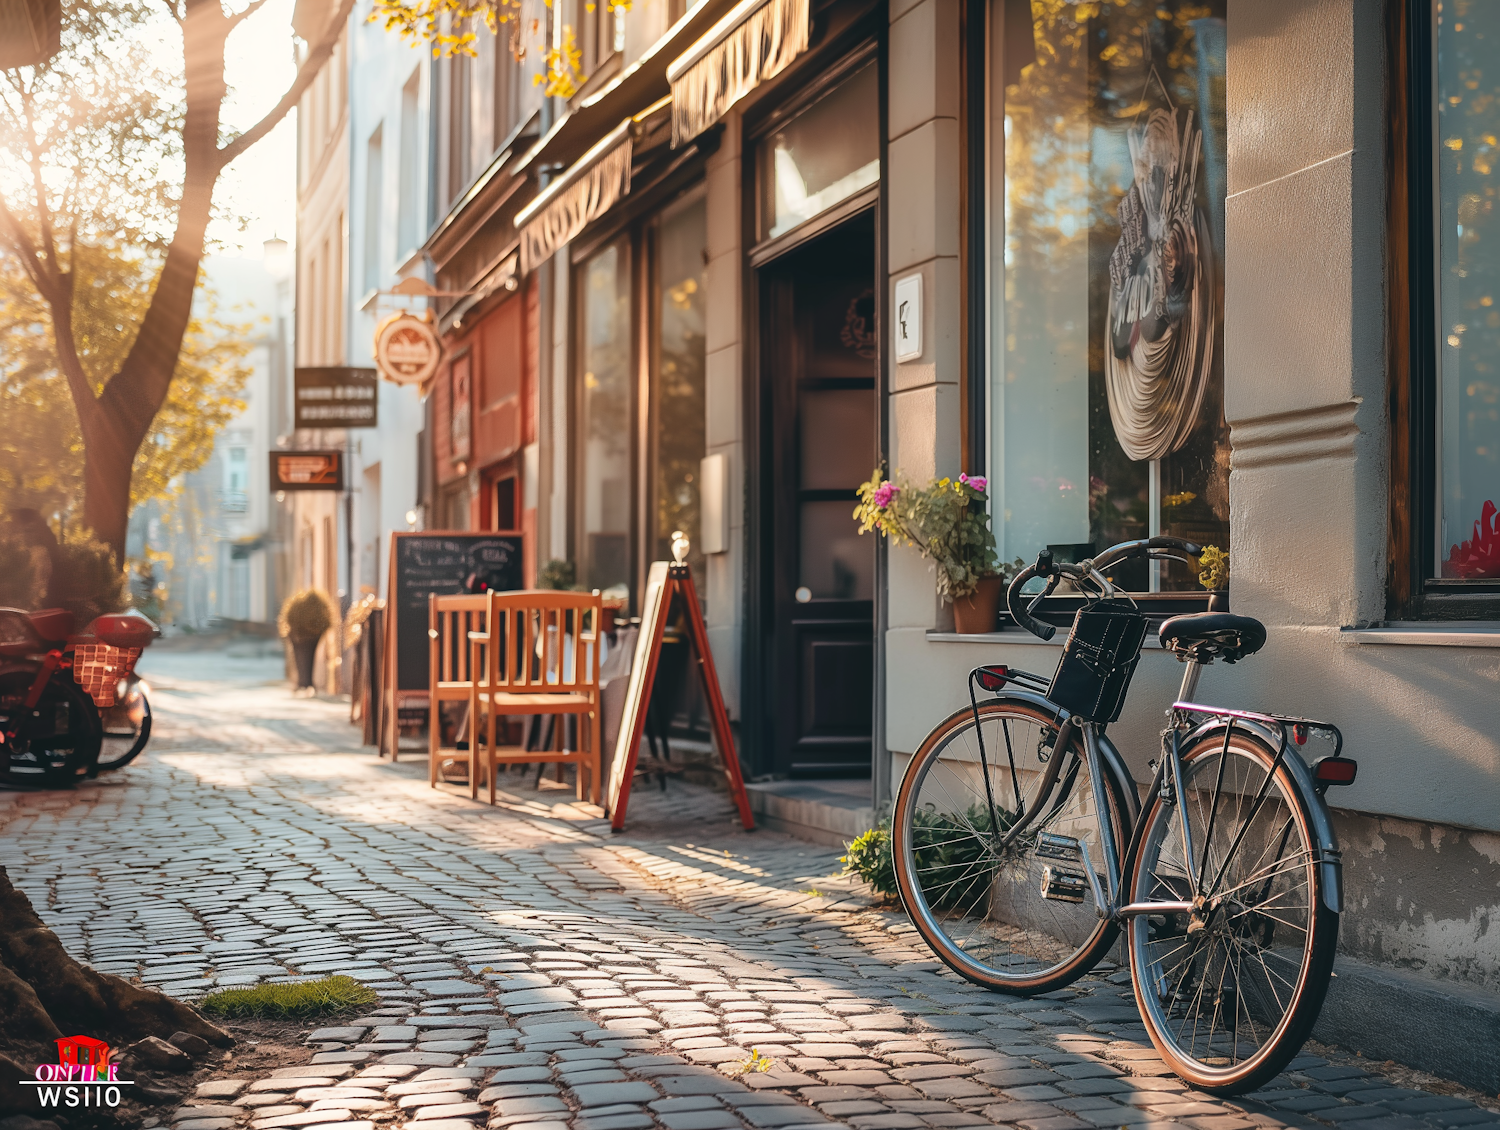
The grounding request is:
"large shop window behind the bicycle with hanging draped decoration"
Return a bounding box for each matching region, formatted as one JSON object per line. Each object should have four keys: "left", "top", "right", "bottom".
{"left": 989, "top": 0, "right": 1230, "bottom": 591}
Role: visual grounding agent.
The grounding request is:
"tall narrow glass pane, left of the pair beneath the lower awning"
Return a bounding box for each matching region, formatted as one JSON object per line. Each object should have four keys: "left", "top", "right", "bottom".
{"left": 578, "top": 239, "right": 632, "bottom": 594}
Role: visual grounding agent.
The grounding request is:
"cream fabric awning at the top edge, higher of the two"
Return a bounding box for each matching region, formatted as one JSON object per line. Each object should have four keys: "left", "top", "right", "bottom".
{"left": 668, "top": 0, "right": 812, "bottom": 149}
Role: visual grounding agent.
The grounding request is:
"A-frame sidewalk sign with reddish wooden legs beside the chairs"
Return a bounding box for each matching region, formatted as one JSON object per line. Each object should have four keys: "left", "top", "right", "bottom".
{"left": 609, "top": 536, "right": 755, "bottom": 831}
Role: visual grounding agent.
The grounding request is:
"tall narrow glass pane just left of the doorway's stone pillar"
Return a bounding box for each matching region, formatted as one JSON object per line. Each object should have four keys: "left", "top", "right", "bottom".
{"left": 651, "top": 195, "right": 708, "bottom": 576}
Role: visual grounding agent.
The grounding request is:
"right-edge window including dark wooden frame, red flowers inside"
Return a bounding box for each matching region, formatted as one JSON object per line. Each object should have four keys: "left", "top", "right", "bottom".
{"left": 1389, "top": 0, "right": 1500, "bottom": 620}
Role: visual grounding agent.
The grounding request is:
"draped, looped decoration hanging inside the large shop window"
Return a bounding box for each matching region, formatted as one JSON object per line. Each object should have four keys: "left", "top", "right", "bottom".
{"left": 1106, "top": 102, "right": 1218, "bottom": 459}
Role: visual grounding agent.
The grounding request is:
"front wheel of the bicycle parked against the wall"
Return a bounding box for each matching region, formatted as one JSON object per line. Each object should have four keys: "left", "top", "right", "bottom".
{"left": 891, "top": 698, "right": 1128, "bottom": 993}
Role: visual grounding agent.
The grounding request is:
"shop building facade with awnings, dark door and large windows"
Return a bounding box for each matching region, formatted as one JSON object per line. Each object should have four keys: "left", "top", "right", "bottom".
{"left": 390, "top": 0, "right": 1500, "bottom": 1085}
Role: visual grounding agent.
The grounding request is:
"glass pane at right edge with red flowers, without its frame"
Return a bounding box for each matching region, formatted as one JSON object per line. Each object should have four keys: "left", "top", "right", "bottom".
{"left": 1433, "top": 0, "right": 1500, "bottom": 581}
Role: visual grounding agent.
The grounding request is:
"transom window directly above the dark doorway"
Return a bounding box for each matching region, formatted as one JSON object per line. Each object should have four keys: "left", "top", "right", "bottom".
{"left": 759, "top": 63, "right": 881, "bottom": 239}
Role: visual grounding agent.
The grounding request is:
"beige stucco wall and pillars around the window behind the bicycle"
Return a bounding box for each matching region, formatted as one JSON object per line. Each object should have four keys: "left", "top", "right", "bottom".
{"left": 885, "top": 0, "right": 1500, "bottom": 987}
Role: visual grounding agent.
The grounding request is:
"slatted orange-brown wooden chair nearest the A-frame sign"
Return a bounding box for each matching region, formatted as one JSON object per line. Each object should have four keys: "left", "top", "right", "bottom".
{"left": 470, "top": 590, "right": 603, "bottom": 804}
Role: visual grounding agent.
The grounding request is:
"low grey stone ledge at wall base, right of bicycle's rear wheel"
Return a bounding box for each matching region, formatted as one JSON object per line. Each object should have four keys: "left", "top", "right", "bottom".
{"left": 1313, "top": 954, "right": 1500, "bottom": 1094}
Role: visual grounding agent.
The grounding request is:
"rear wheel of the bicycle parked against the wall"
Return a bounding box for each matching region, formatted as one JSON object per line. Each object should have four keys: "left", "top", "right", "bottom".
{"left": 1127, "top": 731, "right": 1338, "bottom": 1095}
